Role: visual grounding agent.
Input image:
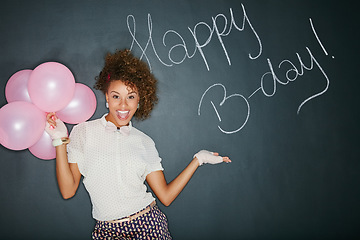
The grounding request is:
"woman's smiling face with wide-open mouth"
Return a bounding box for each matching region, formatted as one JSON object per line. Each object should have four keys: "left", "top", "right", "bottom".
{"left": 105, "top": 80, "right": 140, "bottom": 127}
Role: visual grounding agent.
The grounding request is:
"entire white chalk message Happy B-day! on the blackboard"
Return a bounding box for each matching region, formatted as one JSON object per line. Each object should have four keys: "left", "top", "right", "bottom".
{"left": 127, "top": 4, "right": 334, "bottom": 134}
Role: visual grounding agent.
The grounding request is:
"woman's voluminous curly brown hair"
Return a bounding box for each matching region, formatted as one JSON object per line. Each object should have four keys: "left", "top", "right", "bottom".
{"left": 94, "top": 49, "right": 158, "bottom": 120}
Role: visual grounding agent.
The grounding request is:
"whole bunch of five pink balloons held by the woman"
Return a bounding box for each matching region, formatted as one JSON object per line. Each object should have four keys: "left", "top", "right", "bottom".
{"left": 0, "top": 62, "right": 96, "bottom": 160}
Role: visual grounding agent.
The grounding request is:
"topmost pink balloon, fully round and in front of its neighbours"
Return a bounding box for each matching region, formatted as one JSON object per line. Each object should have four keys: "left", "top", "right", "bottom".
{"left": 28, "top": 62, "right": 75, "bottom": 112}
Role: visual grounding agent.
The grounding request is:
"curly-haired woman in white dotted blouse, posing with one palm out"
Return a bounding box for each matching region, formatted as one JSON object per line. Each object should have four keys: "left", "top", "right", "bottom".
{"left": 46, "top": 50, "right": 231, "bottom": 239}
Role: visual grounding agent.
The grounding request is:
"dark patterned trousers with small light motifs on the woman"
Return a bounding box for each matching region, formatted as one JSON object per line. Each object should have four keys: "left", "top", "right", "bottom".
{"left": 92, "top": 206, "right": 172, "bottom": 240}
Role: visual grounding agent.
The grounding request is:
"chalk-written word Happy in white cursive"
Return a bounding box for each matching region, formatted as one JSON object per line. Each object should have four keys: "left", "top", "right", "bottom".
{"left": 127, "top": 4, "right": 262, "bottom": 71}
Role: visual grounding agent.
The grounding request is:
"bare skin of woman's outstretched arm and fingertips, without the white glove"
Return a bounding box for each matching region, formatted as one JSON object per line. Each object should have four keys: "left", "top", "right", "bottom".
{"left": 146, "top": 153, "right": 231, "bottom": 206}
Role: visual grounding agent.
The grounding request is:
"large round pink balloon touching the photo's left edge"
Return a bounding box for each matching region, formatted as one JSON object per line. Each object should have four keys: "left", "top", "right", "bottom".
{"left": 0, "top": 101, "right": 46, "bottom": 150}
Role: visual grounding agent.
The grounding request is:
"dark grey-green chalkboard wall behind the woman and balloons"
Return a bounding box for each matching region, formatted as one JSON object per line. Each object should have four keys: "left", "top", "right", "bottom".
{"left": 0, "top": 0, "right": 360, "bottom": 239}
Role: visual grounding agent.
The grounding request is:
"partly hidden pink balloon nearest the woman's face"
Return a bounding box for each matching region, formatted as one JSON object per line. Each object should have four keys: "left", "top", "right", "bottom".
{"left": 56, "top": 83, "right": 96, "bottom": 124}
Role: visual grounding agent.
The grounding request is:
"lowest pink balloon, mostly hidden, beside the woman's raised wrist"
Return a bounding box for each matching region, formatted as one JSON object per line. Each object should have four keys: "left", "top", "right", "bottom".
{"left": 29, "top": 131, "right": 56, "bottom": 160}
